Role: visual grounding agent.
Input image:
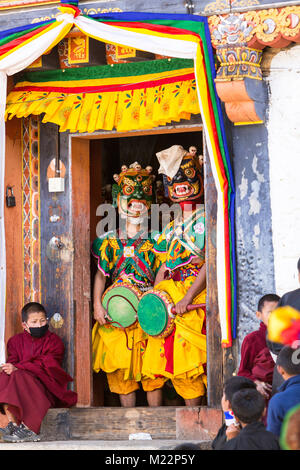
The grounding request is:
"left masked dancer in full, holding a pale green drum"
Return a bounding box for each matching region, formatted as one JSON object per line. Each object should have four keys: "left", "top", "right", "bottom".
{"left": 92, "top": 163, "right": 163, "bottom": 407}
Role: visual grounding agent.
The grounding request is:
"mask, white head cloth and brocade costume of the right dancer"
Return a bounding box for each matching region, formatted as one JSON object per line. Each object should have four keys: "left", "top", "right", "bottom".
{"left": 142, "top": 146, "right": 207, "bottom": 399}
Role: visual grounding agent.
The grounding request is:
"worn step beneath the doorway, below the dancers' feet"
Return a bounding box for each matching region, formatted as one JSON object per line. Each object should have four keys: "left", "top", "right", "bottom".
{"left": 41, "top": 406, "right": 222, "bottom": 445}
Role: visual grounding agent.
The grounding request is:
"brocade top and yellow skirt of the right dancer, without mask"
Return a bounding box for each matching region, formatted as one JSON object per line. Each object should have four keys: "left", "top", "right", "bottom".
{"left": 142, "top": 206, "right": 206, "bottom": 399}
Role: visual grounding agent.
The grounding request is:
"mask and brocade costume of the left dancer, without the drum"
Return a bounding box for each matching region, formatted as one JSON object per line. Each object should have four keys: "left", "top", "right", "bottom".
{"left": 92, "top": 162, "right": 169, "bottom": 395}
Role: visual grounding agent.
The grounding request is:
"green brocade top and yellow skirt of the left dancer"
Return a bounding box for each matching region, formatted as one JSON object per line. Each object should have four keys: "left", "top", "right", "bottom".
{"left": 92, "top": 229, "right": 159, "bottom": 393}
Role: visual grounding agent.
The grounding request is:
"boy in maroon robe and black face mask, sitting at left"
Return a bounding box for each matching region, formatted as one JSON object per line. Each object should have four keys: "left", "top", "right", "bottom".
{"left": 0, "top": 302, "right": 77, "bottom": 442}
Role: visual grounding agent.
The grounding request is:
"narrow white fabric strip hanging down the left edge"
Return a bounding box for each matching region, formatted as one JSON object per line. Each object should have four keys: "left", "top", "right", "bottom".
{"left": 0, "top": 72, "right": 7, "bottom": 365}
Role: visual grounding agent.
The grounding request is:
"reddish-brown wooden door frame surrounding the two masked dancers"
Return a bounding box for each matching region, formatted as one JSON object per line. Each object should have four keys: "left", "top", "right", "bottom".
{"left": 70, "top": 124, "right": 223, "bottom": 407}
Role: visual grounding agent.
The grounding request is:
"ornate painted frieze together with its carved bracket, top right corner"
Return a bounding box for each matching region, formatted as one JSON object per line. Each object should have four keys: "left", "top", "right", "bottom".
{"left": 208, "top": 5, "right": 300, "bottom": 125}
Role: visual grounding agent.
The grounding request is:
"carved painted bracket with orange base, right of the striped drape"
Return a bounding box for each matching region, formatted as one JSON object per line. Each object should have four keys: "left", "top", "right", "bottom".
{"left": 210, "top": 14, "right": 267, "bottom": 125}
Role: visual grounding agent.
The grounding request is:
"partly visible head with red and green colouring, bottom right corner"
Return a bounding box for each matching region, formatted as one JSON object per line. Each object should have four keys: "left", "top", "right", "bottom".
{"left": 280, "top": 405, "right": 300, "bottom": 450}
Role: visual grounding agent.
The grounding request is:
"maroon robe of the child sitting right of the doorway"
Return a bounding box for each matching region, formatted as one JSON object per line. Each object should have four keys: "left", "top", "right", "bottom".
{"left": 237, "top": 322, "right": 275, "bottom": 385}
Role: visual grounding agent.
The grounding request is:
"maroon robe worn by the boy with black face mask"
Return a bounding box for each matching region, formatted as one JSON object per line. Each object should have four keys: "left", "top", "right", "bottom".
{"left": 0, "top": 330, "right": 77, "bottom": 433}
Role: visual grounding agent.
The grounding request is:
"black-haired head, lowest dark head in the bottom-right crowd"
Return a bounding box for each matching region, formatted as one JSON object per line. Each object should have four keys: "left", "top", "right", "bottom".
{"left": 231, "top": 388, "right": 265, "bottom": 426}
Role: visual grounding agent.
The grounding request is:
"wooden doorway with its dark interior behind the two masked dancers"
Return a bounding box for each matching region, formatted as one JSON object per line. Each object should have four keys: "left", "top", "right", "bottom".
{"left": 70, "top": 124, "right": 223, "bottom": 406}
